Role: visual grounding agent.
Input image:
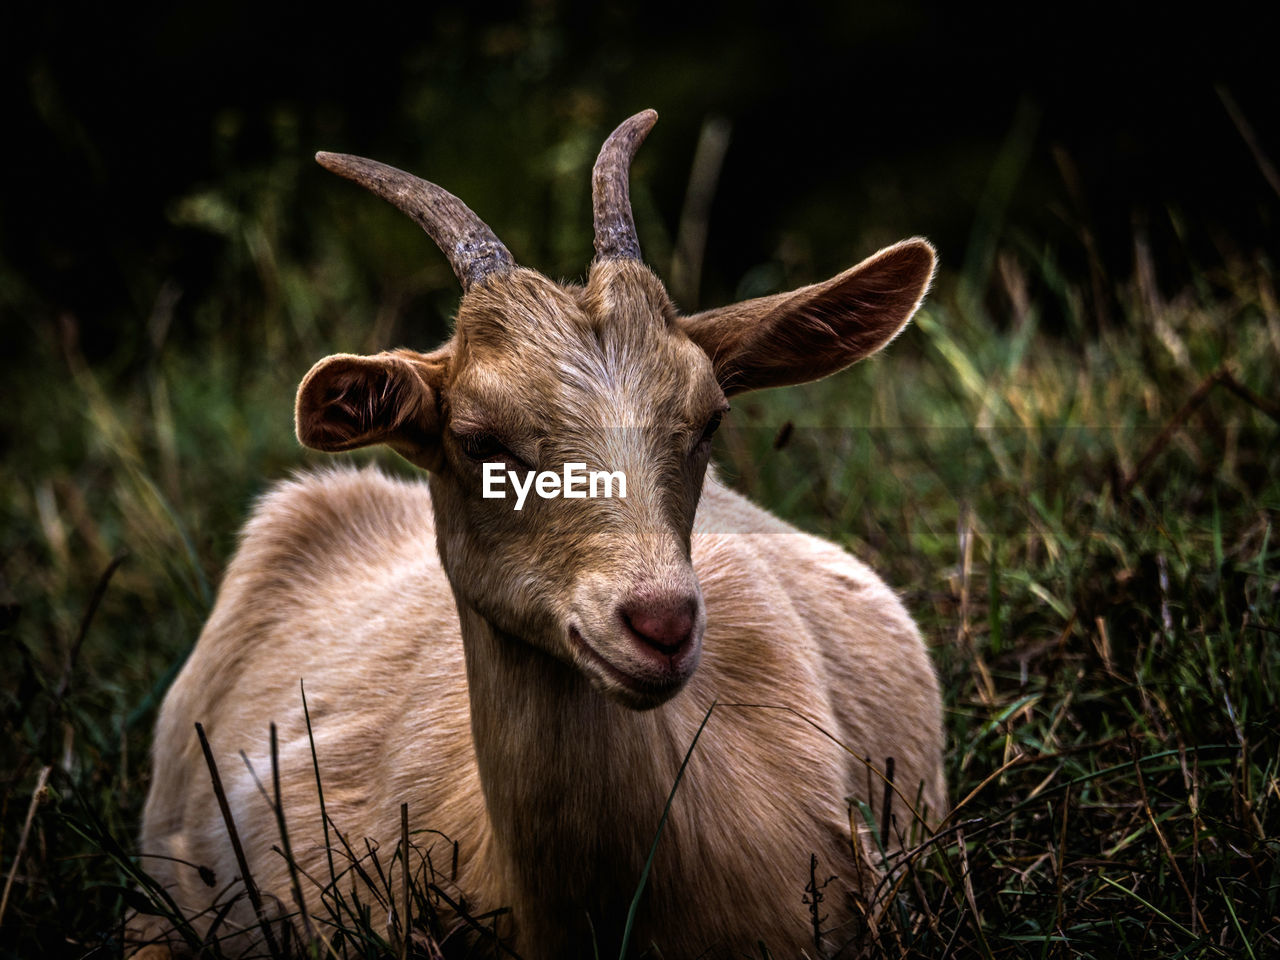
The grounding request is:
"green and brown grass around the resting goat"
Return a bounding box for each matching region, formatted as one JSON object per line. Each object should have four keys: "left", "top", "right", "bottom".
{"left": 0, "top": 160, "right": 1280, "bottom": 957}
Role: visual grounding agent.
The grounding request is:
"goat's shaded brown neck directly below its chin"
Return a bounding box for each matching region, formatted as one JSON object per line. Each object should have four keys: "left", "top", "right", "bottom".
{"left": 460, "top": 607, "right": 680, "bottom": 923}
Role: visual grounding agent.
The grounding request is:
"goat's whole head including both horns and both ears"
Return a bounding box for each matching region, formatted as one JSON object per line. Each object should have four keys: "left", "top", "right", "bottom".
{"left": 297, "top": 110, "right": 933, "bottom": 709}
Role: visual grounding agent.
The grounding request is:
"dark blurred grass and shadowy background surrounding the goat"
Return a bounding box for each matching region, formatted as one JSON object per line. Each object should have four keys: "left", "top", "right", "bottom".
{"left": 0, "top": 3, "right": 1280, "bottom": 956}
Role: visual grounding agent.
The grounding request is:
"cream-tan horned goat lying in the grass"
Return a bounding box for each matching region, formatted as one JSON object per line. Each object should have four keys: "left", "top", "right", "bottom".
{"left": 132, "top": 110, "right": 946, "bottom": 957}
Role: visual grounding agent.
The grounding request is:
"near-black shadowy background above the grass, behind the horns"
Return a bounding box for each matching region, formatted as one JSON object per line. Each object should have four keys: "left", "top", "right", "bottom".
{"left": 0, "top": 0, "right": 1280, "bottom": 369}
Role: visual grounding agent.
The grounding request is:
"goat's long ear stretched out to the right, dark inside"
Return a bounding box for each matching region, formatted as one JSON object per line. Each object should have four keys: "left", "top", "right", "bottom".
{"left": 680, "top": 238, "right": 934, "bottom": 394}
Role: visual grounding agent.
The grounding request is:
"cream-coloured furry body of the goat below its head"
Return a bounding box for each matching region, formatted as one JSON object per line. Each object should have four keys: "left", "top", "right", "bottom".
{"left": 143, "top": 470, "right": 945, "bottom": 957}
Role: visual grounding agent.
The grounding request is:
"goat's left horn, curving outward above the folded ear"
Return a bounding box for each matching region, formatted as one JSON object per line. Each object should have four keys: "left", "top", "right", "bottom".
{"left": 316, "top": 151, "right": 516, "bottom": 292}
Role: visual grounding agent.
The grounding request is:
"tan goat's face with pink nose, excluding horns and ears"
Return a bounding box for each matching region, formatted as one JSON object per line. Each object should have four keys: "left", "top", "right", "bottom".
{"left": 431, "top": 260, "right": 728, "bottom": 708}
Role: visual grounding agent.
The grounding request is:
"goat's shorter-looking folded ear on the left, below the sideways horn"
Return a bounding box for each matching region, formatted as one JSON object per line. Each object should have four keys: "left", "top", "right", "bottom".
{"left": 294, "top": 351, "right": 448, "bottom": 467}
